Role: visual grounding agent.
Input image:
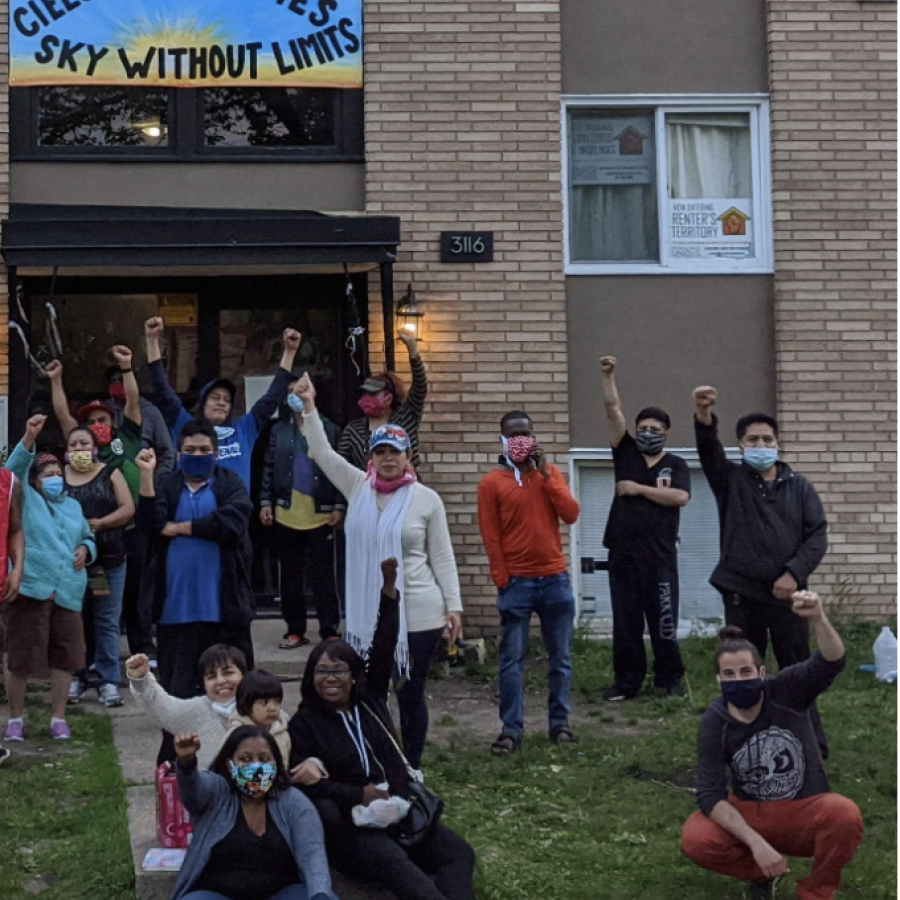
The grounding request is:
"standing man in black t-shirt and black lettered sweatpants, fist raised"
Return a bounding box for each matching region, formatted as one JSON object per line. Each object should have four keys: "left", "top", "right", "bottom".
{"left": 600, "top": 356, "right": 691, "bottom": 701}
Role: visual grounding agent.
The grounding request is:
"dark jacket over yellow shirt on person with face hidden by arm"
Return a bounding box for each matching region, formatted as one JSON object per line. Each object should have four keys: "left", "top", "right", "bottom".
{"left": 259, "top": 404, "right": 347, "bottom": 512}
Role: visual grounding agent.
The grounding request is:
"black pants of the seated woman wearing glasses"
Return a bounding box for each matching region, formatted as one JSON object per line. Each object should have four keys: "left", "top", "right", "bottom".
{"left": 316, "top": 800, "right": 475, "bottom": 900}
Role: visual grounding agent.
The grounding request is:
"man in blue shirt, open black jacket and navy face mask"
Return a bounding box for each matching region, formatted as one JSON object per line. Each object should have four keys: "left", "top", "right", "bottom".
{"left": 136, "top": 422, "right": 255, "bottom": 697}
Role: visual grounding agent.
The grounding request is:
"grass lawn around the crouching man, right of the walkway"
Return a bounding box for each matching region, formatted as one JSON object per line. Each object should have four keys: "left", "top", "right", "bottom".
{"left": 425, "top": 625, "right": 897, "bottom": 900}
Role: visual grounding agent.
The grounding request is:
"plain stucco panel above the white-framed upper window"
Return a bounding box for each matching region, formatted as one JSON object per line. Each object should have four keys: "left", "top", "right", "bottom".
{"left": 561, "top": 0, "right": 768, "bottom": 94}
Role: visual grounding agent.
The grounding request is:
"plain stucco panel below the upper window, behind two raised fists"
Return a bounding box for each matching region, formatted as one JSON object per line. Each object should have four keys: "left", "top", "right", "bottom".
{"left": 566, "top": 275, "right": 775, "bottom": 447}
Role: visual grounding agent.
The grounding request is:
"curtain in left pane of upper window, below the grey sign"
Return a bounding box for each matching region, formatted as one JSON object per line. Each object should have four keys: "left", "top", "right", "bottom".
{"left": 570, "top": 184, "right": 659, "bottom": 262}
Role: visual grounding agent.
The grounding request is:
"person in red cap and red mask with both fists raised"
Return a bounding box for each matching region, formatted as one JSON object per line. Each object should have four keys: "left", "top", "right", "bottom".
{"left": 47, "top": 344, "right": 144, "bottom": 502}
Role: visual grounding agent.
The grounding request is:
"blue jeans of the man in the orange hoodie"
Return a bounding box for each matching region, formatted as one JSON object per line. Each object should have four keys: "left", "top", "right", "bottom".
{"left": 497, "top": 572, "right": 575, "bottom": 740}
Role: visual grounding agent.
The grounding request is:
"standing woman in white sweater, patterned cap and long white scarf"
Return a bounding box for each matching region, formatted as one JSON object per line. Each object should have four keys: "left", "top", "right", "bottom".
{"left": 289, "top": 373, "right": 462, "bottom": 769}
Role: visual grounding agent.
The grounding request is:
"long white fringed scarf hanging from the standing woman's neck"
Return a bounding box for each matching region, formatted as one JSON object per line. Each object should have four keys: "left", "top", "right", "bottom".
{"left": 344, "top": 472, "right": 415, "bottom": 676}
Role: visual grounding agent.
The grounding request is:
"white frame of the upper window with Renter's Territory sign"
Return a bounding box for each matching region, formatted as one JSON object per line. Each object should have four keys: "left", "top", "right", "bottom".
{"left": 561, "top": 94, "right": 774, "bottom": 275}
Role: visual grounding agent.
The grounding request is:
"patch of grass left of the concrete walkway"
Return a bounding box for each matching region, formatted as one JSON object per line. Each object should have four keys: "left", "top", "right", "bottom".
{"left": 0, "top": 695, "right": 134, "bottom": 900}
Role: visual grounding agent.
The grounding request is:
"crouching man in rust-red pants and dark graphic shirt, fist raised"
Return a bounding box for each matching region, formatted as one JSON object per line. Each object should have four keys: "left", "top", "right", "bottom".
{"left": 681, "top": 591, "right": 863, "bottom": 900}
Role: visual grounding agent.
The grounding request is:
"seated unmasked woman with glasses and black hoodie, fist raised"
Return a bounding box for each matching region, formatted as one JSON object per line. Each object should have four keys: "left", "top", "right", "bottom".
{"left": 289, "top": 559, "right": 475, "bottom": 900}
